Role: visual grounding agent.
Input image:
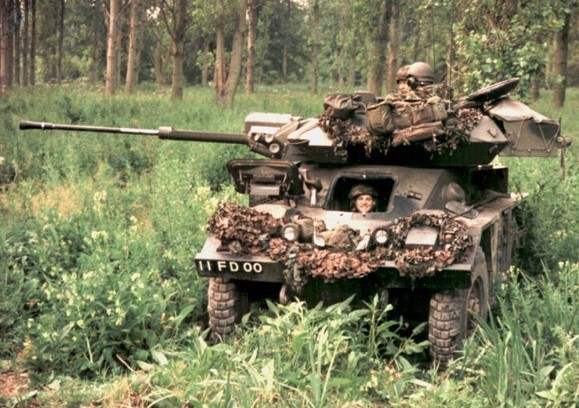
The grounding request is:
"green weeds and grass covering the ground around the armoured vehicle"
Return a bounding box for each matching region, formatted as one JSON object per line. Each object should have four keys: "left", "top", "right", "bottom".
{"left": 0, "top": 87, "right": 579, "bottom": 407}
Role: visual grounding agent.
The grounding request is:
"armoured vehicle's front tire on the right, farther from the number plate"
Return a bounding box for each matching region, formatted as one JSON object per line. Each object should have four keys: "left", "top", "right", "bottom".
{"left": 428, "top": 247, "right": 489, "bottom": 370}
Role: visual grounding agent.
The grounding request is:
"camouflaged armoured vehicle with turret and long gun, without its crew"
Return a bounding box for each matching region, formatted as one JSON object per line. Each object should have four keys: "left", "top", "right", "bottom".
{"left": 20, "top": 69, "right": 567, "bottom": 366}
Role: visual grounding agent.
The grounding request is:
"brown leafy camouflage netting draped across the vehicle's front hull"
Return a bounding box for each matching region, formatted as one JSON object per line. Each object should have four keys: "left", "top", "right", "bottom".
{"left": 208, "top": 203, "right": 472, "bottom": 293}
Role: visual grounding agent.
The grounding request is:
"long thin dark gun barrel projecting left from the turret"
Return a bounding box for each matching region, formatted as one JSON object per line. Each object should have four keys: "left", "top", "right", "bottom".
{"left": 19, "top": 120, "right": 249, "bottom": 145}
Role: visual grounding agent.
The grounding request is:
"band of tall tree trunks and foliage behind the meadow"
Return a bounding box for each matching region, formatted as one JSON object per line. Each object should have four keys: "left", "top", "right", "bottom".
{"left": 0, "top": 0, "right": 579, "bottom": 106}
